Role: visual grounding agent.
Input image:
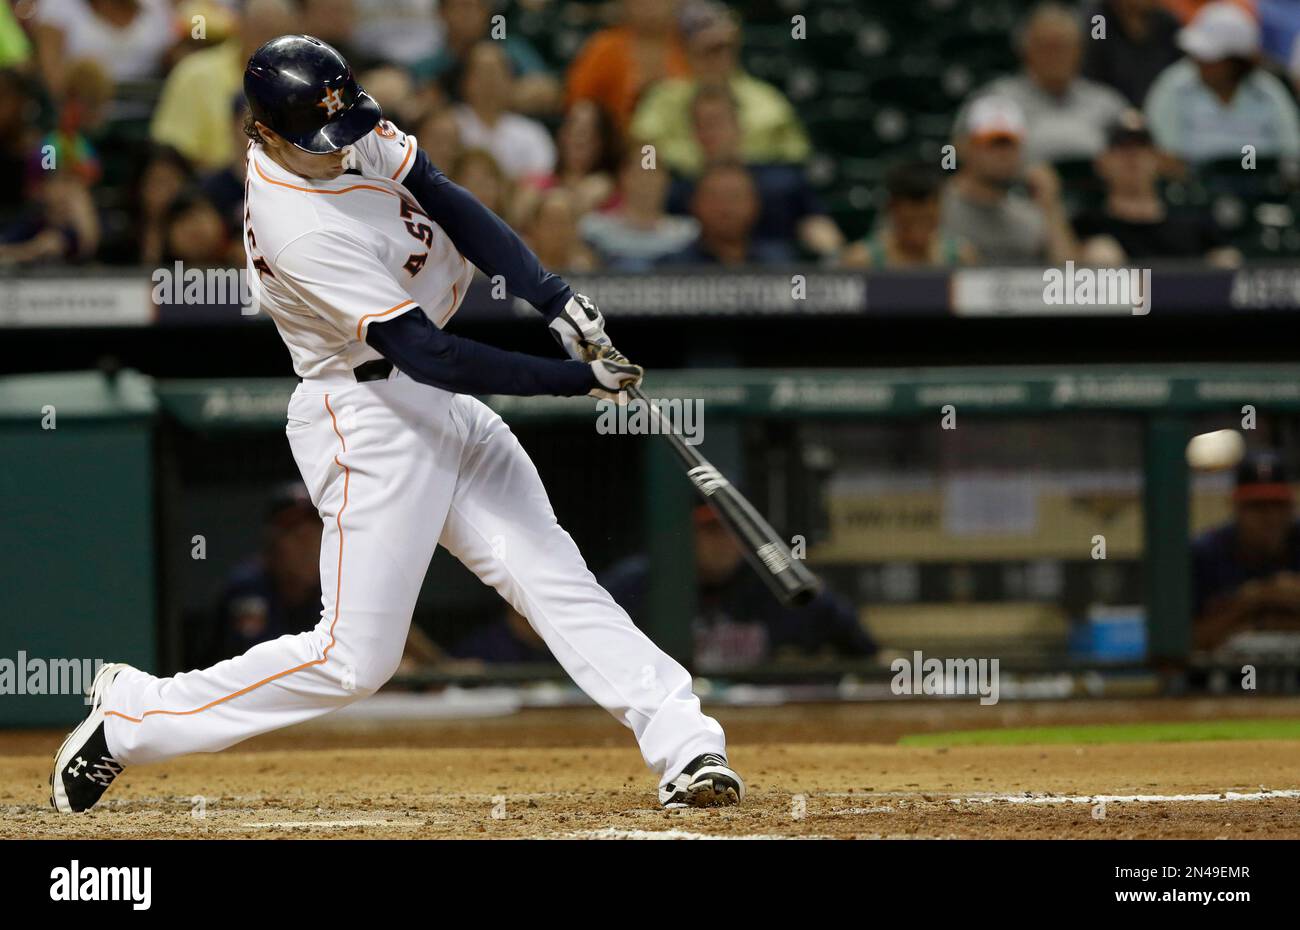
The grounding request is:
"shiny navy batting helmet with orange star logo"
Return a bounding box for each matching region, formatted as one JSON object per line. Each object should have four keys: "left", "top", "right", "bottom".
{"left": 244, "top": 35, "right": 381, "bottom": 155}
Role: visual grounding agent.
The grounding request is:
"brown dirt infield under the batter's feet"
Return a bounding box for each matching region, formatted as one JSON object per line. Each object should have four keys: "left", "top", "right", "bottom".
{"left": 0, "top": 698, "right": 1300, "bottom": 838}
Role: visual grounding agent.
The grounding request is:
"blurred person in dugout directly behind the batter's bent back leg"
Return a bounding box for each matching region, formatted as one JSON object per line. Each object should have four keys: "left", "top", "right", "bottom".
{"left": 205, "top": 481, "right": 443, "bottom": 669}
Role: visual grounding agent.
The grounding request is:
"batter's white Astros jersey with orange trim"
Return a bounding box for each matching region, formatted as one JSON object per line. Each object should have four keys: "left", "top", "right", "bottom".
{"left": 244, "top": 120, "right": 475, "bottom": 379}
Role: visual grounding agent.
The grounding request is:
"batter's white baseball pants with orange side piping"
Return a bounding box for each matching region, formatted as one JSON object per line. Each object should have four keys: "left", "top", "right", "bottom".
{"left": 104, "top": 372, "right": 725, "bottom": 784}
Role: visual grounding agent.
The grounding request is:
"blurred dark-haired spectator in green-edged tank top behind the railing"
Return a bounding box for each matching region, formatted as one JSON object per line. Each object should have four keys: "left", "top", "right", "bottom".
{"left": 844, "top": 161, "right": 975, "bottom": 268}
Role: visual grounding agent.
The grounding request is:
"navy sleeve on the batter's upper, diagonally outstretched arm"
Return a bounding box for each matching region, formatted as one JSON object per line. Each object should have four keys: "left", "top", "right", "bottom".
{"left": 402, "top": 151, "right": 573, "bottom": 323}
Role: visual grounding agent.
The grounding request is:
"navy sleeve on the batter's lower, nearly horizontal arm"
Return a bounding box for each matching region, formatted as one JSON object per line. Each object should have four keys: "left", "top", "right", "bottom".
{"left": 365, "top": 307, "right": 595, "bottom": 397}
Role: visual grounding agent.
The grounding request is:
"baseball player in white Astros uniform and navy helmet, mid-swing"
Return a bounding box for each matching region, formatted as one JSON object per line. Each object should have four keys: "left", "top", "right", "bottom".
{"left": 49, "top": 35, "right": 743, "bottom": 813}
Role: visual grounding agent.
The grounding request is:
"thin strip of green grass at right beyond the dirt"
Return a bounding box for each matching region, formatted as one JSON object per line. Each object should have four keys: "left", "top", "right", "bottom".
{"left": 898, "top": 719, "right": 1300, "bottom": 747}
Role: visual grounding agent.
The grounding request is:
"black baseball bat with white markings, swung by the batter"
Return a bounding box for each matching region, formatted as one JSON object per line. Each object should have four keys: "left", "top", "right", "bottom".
{"left": 628, "top": 388, "right": 822, "bottom": 607}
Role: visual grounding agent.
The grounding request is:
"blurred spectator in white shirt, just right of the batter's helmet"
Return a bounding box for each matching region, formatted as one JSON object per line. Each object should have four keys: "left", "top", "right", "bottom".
{"left": 455, "top": 40, "right": 555, "bottom": 179}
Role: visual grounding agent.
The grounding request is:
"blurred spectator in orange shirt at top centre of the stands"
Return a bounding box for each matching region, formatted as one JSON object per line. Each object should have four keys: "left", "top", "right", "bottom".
{"left": 566, "top": 0, "right": 690, "bottom": 130}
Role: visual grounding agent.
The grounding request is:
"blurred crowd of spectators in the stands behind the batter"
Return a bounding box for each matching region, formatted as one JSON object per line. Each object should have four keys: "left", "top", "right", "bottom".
{"left": 0, "top": 0, "right": 1300, "bottom": 271}
